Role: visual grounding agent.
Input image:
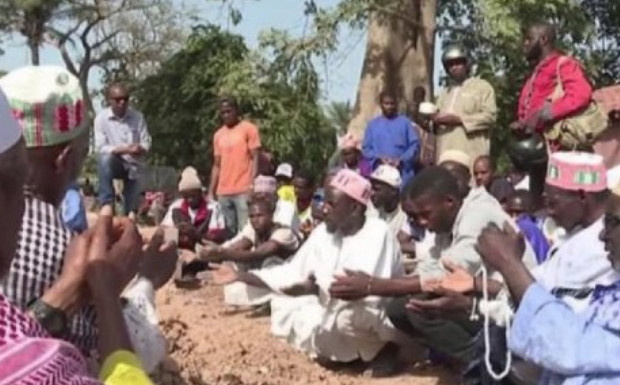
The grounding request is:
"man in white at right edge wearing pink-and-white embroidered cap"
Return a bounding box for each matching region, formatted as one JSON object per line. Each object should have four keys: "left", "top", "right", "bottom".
{"left": 533, "top": 152, "right": 620, "bottom": 312}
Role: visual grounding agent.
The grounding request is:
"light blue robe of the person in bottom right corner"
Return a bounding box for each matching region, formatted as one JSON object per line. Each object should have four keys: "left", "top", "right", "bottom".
{"left": 509, "top": 283, "right": 620, "bottom": 385}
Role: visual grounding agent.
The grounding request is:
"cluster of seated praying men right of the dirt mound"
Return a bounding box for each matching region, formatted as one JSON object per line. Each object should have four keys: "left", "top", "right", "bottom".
{"left": 162, "top": 134, "right": 620, "bottom": 384}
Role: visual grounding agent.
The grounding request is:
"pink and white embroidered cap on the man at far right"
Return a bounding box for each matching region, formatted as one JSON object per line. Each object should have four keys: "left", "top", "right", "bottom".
{"left": 546, "top": 152, "right": 607, "bottom": 192}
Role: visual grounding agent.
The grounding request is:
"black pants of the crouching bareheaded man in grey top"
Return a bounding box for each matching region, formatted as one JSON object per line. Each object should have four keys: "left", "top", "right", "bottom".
{"left": 387, "top": 294, "right": 481, "bottom": 363}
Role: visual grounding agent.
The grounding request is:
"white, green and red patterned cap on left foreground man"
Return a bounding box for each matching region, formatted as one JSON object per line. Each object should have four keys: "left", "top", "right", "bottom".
{"left": 0, "top": 66, "right": 88, "bottom": 148}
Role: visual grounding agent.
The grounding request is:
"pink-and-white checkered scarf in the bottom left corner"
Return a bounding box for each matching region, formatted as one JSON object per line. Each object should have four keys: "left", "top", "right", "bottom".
{"left": 0, "top": 295, "right": 101, "bottom": 385}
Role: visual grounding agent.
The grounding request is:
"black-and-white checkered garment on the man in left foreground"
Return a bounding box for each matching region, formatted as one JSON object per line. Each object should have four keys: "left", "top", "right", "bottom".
{"left": 0, "top": 197, "right": 97, "bottom": 354}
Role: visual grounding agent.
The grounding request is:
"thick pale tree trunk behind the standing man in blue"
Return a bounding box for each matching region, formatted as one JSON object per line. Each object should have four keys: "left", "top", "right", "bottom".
{"left": 348, "top": 0, "right": 437, "bottom": 138}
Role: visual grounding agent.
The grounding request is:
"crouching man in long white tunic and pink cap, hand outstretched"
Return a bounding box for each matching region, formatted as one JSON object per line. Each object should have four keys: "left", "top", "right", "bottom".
{"left": 214, "top": 170, "right": 403, "bottom": 375}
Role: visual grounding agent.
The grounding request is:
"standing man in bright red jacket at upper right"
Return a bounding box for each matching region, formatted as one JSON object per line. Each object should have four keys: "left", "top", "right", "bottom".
{"left": 511, "top": 22, "right": 592, "bottom": 204}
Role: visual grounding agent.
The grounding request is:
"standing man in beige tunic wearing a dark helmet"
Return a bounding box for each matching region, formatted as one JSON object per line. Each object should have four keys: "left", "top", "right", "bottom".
{"left": 433, "top": 46, "right": 497, "bottom": 164}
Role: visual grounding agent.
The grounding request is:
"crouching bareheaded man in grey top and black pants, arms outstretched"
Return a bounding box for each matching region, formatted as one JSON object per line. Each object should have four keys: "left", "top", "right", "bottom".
{"left": 331, "top": 167, "right": 535, "bottom": 364}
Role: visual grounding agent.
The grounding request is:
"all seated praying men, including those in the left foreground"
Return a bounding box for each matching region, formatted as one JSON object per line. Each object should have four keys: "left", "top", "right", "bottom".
{"left": 0, "top": 63, "right": 620, "bottom": 385}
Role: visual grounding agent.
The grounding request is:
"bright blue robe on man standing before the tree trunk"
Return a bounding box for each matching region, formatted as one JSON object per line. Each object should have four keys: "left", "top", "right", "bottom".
{"left": 362, "top": 115, "right": 420, "bottom": 186}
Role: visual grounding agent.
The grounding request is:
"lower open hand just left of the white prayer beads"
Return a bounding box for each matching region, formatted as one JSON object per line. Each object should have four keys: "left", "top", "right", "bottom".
{"left": 406, "top": 288, "right": 473, "bottom": 317}
